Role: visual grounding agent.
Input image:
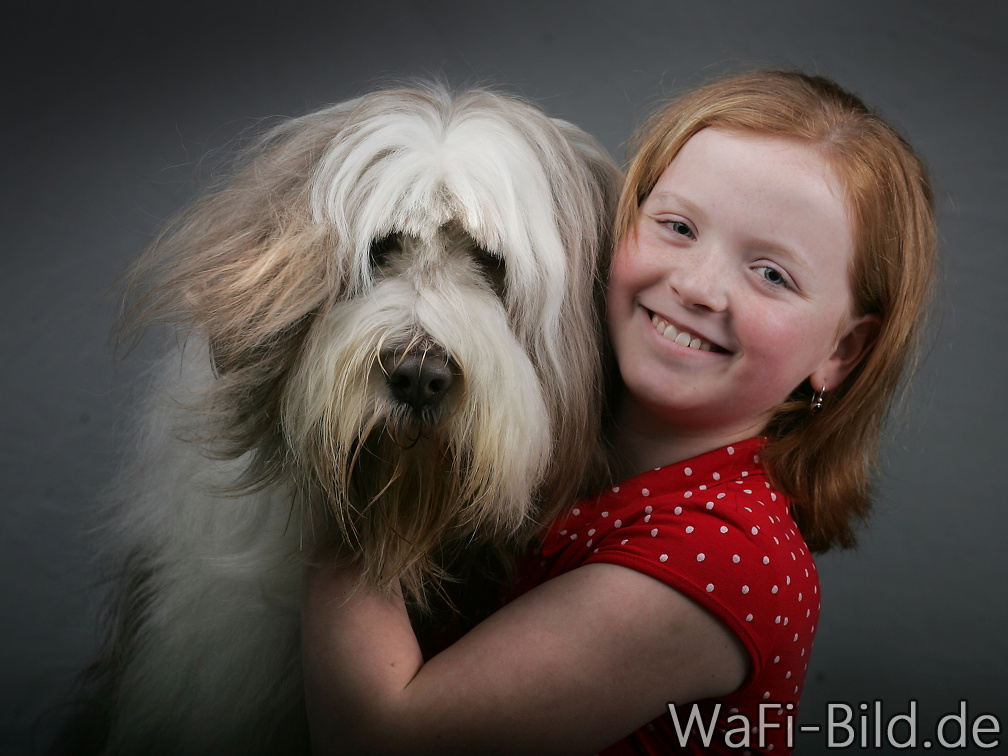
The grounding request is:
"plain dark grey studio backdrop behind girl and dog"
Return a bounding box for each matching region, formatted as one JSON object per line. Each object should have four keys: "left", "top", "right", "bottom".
{"left": 0, "top": 0, "right": 1008, "bottom": 753}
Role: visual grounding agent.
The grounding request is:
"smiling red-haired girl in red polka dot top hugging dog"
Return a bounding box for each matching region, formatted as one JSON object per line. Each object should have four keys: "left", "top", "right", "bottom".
{"left": 302, "top": 72, "right": 935, "bottom": 754}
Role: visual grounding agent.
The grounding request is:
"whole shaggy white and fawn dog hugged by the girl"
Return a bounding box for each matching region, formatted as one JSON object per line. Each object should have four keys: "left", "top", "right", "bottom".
{"left": 59, "top": 86, "right": 619, "bottom": 756}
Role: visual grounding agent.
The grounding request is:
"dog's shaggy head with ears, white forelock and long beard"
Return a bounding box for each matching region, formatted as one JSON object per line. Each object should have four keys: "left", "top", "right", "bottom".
{"left": 127, "top": 89, "right": 618, "bottom": 592}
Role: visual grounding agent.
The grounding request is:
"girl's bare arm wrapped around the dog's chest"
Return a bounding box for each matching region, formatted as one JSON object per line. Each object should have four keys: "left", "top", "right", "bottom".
{"left": 302, "top": 564, "right": 748, "bottom": 754}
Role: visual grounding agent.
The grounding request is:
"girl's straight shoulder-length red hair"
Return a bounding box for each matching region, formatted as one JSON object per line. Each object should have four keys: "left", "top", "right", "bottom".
{"left": 616, "top": 71, "right": 937, "bottom": 551}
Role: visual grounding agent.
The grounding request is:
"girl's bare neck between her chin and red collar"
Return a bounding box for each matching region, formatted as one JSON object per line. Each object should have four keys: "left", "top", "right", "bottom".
{"left": 609, "top": 396, "right": 759, "bottom": 483}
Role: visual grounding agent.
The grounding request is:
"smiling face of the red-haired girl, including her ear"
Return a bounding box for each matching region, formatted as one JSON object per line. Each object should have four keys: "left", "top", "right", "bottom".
{"left": 607, "top": 128, "right": 875, "bottom": 444}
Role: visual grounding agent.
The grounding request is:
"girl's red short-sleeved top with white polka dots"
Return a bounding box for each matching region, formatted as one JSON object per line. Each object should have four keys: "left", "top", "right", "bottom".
{"left": 519, "top": 438, "right": 820, "bottom": 756}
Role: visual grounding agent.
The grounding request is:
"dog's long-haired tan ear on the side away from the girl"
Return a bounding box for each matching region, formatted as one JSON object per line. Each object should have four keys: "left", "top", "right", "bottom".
{"left": 117, "top": 109, "right": 362, "bottom": 481}
